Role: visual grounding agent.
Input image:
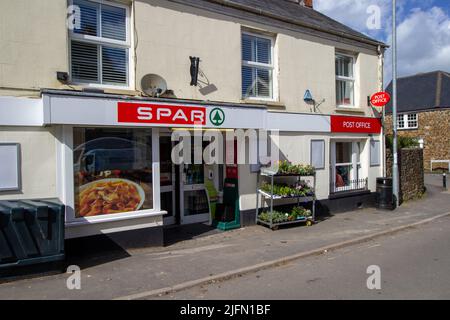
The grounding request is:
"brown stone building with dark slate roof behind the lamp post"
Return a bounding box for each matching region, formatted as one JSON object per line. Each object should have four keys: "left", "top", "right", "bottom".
{"left": 386, "top": 71, "right": 450, "bottom": 171}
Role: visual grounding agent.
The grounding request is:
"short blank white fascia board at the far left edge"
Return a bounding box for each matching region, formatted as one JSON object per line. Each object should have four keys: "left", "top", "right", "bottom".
{"left": 0, "top": 97, "right": 44, "bottom": 126}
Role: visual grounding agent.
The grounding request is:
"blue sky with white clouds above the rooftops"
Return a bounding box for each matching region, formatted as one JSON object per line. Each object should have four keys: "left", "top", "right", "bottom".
{"left": 314, "top": 0, "right": 450, "bottom": 83}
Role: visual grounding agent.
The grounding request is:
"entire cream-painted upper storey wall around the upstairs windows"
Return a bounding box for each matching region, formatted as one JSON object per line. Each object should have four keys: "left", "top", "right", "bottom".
{"left": 0, "top": 0, "right": 379, "bottom": 115}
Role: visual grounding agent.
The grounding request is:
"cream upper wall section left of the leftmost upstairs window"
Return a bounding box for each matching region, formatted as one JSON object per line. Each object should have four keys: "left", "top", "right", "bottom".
{"left": 0, "top": 0, "right": 69, "bottom": 95}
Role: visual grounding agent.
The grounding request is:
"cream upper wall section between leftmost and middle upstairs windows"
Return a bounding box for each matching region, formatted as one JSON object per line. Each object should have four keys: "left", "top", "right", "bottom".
{"left": 135, "top": 1, "right": 241, "bottom": 102}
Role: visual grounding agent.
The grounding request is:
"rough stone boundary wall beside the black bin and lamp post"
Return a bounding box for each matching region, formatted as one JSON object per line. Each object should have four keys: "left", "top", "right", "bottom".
{"left": 386, "top": 148, "right": 425, "bottom": 202}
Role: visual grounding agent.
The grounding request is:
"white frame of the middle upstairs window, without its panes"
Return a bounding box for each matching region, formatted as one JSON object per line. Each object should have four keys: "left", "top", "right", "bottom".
{"left": 241, "top": 30, "right": 278, "bottom": 101}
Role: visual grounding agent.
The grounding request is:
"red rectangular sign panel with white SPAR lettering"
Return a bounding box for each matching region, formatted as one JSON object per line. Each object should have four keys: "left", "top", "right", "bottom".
{"left": 117, "top": 102, "right": 207, "bottom": 126}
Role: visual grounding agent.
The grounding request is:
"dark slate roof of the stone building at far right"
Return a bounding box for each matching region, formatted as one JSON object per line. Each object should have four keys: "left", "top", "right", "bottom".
{"left": 386, "top": 71, "right": 450, "bottom": 113}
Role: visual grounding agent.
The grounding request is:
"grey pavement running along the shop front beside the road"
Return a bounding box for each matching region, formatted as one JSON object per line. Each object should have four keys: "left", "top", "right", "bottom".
{"left": 0, "top": 180, "right": 450, "bottom": 300}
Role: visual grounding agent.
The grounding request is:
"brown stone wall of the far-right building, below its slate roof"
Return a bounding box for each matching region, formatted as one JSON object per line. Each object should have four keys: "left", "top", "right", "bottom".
{"left": 385, "top": 109, "right": 450, "bottom": 171}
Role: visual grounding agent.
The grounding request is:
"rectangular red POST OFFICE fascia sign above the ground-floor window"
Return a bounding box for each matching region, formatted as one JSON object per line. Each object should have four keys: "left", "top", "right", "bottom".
{"left": 331, "top": 116, "right": 381, "bottom": 133}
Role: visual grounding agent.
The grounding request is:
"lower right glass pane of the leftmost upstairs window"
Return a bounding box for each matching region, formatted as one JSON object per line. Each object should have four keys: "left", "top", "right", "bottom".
{"left": 102, "top": 47, "right": 128, "bottom": 84}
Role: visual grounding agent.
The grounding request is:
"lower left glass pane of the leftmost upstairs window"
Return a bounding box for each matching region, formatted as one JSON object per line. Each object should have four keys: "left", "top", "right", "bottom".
{"left": 71, "top": 41, "right": 99, "bottom": 82}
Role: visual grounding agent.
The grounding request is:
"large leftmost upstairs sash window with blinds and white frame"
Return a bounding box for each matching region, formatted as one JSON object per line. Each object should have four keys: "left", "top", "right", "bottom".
{"left": 70, "top": 0, "right": 130, "bottom": 86}
